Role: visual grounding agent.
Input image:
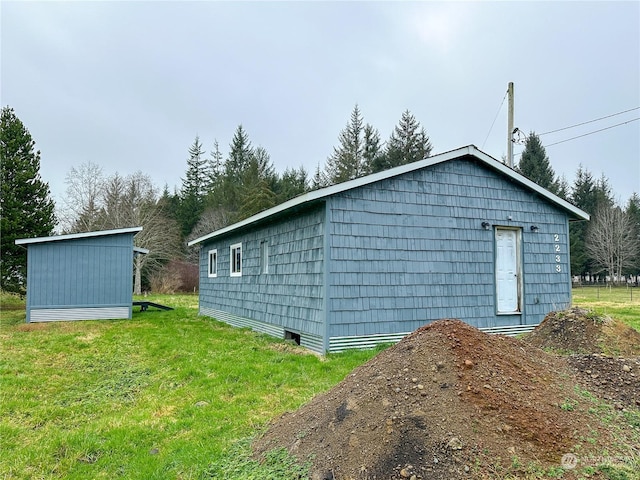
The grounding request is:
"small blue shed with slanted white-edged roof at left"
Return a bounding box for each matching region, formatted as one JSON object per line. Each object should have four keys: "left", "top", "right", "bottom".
{"left": 16, "top": 227, "right": 148, "bottom": 322}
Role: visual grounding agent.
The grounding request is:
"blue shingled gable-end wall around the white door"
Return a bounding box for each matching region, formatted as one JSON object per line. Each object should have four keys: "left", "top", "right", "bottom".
{"left": 328, "top": 159, "right": 570, "bottom": 337}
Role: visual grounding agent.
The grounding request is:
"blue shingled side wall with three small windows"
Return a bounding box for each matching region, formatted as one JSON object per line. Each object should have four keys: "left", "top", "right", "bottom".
{"left": 200, "top": 204, "right": 325, "bottom": 344}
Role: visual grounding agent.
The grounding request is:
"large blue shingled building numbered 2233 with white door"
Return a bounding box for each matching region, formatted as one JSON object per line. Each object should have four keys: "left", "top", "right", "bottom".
{"left": 189, "top": 146, "right": 589, "bottom": 353}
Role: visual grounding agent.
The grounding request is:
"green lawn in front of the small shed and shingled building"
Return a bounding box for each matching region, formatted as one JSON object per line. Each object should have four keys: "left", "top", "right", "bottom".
{"left": 0, "top": 295, "right": 375, "bottom": 479}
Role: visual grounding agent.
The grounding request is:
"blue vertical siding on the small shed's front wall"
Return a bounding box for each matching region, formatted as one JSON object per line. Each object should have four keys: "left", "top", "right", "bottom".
{"left": 27, "top": 233, "right": 133, "bottom": 320}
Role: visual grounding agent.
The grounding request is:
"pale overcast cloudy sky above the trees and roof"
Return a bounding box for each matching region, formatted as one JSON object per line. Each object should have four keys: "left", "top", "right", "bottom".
{"left": 0, "top": 0, "right": 640, "bottom": 210}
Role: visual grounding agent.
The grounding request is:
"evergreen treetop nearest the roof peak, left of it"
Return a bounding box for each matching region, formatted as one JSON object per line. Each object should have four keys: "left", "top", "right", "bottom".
{"left": 373, "top": 110, "right": 432, "bottom": 171}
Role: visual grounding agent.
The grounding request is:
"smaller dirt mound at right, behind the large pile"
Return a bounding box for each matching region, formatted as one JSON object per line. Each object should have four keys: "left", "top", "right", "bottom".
{"left": 524, "top": 308, "right": 640, "bottom": 357}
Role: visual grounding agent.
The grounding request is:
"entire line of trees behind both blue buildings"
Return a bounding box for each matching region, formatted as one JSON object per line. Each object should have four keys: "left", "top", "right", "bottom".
{"left": 0, "top": 104, "right": 640, "bottom": 293}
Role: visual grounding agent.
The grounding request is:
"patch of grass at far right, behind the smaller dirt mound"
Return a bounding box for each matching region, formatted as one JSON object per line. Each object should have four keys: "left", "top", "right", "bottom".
{"left": 572, "top": 286, "right": 640, "bottom": 332}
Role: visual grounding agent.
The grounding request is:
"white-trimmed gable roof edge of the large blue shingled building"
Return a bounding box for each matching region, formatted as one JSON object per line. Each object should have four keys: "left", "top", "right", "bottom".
{"left": 187, "top": 145, "right": 589, "bottom": 246}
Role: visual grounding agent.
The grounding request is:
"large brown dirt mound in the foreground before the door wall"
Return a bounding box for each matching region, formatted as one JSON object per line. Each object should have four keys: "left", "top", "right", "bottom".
{"left": 254, "top": 320, "right": 635, "bottom": 480}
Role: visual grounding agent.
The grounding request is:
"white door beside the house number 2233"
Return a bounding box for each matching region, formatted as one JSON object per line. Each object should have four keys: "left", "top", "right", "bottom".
{"left": 496, "top": 228, "right": 520, "bottom": 313}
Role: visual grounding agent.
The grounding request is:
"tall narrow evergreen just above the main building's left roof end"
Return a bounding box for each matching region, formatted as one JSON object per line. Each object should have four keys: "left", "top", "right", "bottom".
{"left": 179, "top": 135, "right": 209, "bottom": 237}
